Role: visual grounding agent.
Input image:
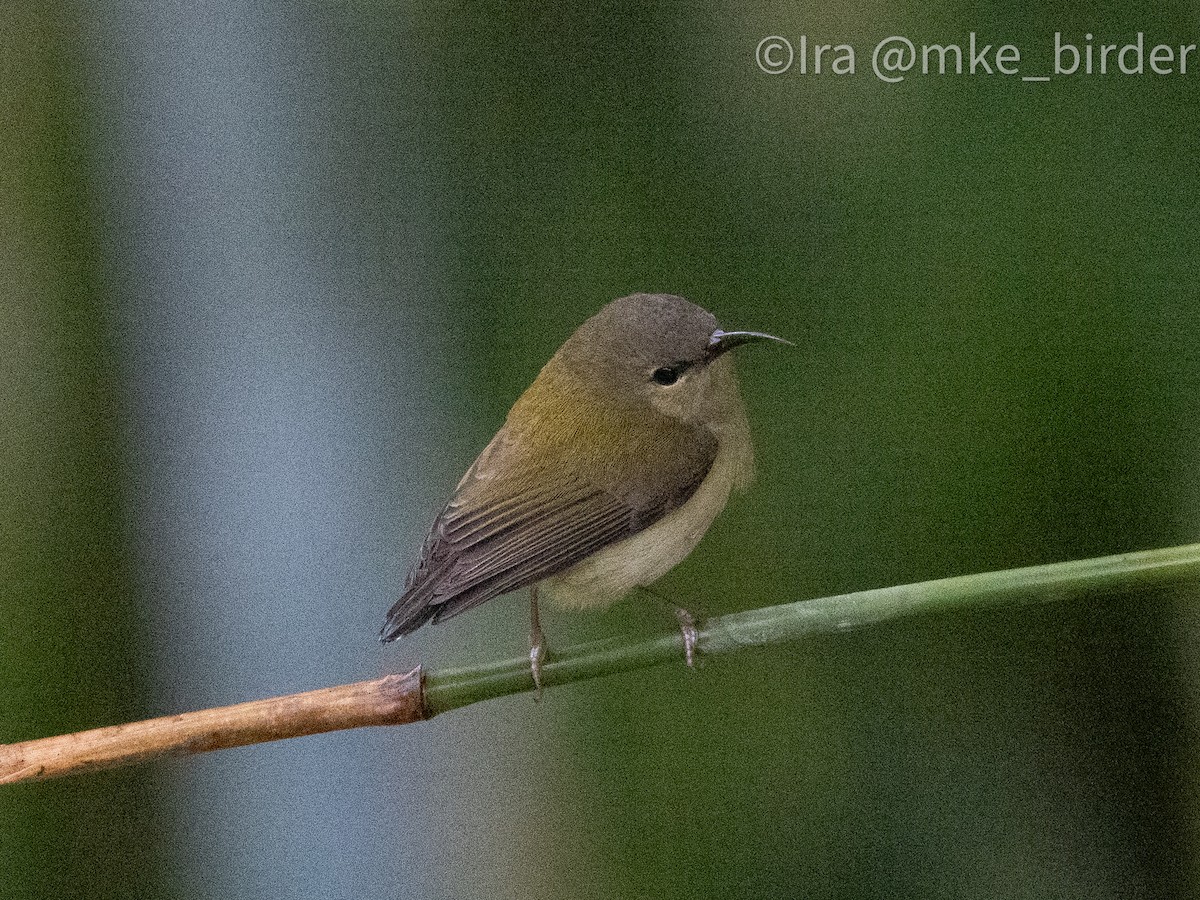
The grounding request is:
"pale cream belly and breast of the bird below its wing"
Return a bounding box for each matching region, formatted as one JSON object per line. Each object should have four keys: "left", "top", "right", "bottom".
{"left": 541, "top": 446, "right": 754, "bottom": 608}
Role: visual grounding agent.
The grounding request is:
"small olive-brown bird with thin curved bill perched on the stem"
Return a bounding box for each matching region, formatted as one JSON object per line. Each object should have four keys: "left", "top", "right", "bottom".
{"left": 379, "top": 294, "right": 788, "bottom": 691}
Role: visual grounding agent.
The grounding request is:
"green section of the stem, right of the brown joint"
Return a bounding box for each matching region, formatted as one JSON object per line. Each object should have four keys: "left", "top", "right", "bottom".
{"left": 425, "top": 544, "right": 1200, "bottom": 715}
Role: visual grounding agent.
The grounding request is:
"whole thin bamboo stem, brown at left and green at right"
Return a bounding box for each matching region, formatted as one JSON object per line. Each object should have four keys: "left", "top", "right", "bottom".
{"left": 0, "top": 544, "right": 1200, "bottom": 785}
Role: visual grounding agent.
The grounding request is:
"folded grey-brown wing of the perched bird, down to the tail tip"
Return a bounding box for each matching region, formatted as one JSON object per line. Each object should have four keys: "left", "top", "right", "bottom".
{"left": 380, "top": 430, "right": 716, "bottom": 641}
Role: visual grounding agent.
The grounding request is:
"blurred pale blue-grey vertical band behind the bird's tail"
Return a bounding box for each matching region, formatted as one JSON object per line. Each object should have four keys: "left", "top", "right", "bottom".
{"left": 79, "top": 2, "right": 453, "bottom": 898}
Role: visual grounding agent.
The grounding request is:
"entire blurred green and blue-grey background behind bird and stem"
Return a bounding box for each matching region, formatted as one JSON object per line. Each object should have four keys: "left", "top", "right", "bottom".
{"left": 0, "top": 0, "right": 1200, "bottom": 900}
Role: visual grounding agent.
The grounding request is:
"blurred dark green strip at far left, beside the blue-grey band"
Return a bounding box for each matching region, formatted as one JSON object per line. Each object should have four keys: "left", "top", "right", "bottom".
{"left": 0, "top": 5, "right": 161, "bottom": 898}
